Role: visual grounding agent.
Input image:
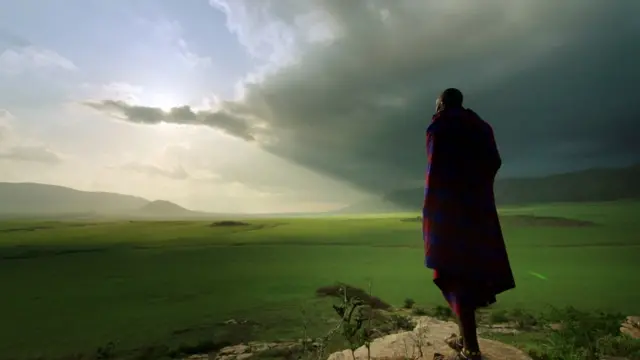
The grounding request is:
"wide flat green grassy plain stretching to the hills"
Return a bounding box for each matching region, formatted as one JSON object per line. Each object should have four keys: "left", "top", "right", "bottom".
{"left": 0, "top": 202, "right": 640, "bottom": 359}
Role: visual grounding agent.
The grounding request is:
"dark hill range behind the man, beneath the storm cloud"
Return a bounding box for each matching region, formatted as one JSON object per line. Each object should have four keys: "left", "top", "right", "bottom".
{"left": 341, "top": 165, "right": 640, "bottom": 213}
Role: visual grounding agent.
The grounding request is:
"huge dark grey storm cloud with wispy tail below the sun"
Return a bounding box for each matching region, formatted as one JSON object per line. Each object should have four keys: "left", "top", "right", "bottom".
{"left": 86, "top": 0, "right": 640, "bottom": 192}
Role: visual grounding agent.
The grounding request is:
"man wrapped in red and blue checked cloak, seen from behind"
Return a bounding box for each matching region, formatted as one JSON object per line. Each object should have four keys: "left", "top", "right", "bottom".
{"left": 422, "top": 88, "right": 515, "bottom": 360}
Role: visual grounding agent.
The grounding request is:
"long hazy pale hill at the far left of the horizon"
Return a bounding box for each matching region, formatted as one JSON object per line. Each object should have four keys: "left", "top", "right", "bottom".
{"left": 0, "top": 182, "right": 149, "bottom": 215}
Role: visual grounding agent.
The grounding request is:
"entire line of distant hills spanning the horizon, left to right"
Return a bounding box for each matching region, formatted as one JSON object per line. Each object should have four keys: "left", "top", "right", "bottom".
{"left": 0, "top": 164, "right": 640, "bottom": 219}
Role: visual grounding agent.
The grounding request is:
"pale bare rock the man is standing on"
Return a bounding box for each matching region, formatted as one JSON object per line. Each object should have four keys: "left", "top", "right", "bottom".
{"left": 329, "top": 316, "right": 531, "bottom": 360}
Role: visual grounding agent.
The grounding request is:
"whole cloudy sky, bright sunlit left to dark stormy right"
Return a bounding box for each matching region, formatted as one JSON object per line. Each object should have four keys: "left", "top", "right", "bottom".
{"left": 0, "top": 0, "right": 640, "bottom": 212}
